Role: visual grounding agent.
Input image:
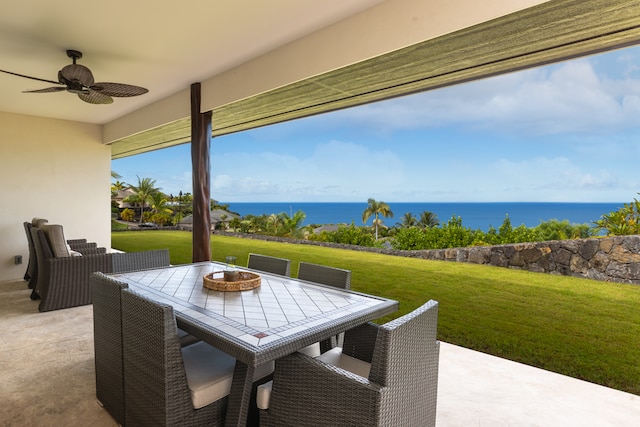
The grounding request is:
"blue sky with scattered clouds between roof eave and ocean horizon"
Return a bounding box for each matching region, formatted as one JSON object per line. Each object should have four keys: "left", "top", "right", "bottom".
{"left": 112, "top": 47, "right": 640, "bottom": 202}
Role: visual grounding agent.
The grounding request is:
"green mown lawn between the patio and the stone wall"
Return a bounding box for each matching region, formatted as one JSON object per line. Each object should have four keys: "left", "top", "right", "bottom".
{"left": 112, "top": 231, "right": 640, "bottom": 395}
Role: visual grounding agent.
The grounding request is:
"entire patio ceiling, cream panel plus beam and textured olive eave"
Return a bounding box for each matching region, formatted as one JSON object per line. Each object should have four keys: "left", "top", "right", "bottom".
{"left": 0, "top": 0, "right": 640, "bottom": 157}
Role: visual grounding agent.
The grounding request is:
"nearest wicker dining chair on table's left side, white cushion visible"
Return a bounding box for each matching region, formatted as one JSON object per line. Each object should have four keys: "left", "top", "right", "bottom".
{"left": 122, "top": 289, "right": 273, "bottom": 427}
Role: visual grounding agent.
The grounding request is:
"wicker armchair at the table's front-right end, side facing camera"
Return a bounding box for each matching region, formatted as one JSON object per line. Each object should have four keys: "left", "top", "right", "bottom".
{"left": 258, "top": 301, "right": 439, "bottom": 427}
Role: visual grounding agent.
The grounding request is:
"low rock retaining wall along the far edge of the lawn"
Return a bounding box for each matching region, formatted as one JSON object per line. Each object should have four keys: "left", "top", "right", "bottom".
{"left": 216, "top": 231, "right": 640, "bottom": 285}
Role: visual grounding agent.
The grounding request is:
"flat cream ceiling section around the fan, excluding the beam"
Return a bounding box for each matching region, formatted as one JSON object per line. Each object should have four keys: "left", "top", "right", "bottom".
{"left": 0, "top": 0, "right": 381, "bottom": 124}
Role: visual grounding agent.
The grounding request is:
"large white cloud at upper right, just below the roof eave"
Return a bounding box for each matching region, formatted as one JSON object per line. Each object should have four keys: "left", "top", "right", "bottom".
{"left": 327, "top": 54, "right": 640, "bottom": 135}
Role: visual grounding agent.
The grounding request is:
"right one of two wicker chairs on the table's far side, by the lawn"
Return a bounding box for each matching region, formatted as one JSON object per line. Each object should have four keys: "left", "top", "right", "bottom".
{"left": 298, "top": 262, "right": 351, "bottom": 357}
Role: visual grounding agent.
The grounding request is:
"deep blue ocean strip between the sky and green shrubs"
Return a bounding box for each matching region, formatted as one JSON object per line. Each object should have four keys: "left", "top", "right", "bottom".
{"left": 222, "top": 202, "right": 624, "bottom": 231}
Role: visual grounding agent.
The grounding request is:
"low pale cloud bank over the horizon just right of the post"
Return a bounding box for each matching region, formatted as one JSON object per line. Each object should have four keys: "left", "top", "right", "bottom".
{"left": 212, "top": 140, "right": 405, "bottom": 201}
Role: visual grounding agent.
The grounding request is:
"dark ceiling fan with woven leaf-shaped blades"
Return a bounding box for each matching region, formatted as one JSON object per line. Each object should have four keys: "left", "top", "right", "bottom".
{"left": 0, "top": 50, "right": 149, "bottom": 104}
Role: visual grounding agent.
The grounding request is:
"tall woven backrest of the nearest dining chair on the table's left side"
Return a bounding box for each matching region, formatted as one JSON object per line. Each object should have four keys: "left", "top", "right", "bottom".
{"left": 122, "top": 290, "right": 193, "bottom": 425}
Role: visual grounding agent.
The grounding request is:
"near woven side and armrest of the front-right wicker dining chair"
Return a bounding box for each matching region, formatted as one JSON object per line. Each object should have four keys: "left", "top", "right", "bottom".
{"left": 260, "top": 353, "right": 385, "bottom": 426}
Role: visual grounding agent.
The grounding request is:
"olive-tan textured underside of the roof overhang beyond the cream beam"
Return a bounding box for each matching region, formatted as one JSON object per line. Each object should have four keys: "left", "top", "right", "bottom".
{"left": 112, "top": 0, "right": 640, "bottom": 158}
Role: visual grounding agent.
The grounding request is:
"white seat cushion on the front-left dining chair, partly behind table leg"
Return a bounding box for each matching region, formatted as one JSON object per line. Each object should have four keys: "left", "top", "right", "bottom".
{"left": 182, "top": 341, "right": 274, "bottom": 409}
